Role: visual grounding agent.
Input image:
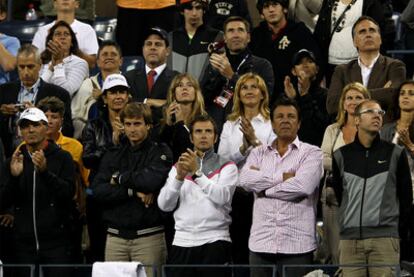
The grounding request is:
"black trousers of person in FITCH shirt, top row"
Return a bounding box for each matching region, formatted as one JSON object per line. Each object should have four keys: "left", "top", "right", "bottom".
{"left": 116, "top": 6, "right": 178, "bottom": 56}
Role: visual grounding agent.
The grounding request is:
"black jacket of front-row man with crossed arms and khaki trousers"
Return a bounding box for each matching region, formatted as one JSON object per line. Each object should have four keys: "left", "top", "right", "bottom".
{"left": 91, "top": 139, "right": 172, "bottom": 235}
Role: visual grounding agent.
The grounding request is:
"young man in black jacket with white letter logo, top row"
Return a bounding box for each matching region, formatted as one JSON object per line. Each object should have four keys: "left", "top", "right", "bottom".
{"left": 249, "top": 0, "right": 319, "bottom": 103}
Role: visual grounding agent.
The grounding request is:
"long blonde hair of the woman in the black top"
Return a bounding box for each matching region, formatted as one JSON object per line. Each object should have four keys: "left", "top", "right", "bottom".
{"left": 164, "top": 73, "right": 206, "bottom": 125}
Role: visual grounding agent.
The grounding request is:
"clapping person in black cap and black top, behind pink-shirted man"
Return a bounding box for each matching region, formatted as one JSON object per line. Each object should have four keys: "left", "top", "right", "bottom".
{"left": 284, "top": 49, "right": 329, "bottom": 146}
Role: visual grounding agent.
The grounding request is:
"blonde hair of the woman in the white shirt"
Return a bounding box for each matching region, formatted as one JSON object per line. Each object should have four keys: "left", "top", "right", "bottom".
{"left": 227, "top": 72, "right": 270, "bottom": 121}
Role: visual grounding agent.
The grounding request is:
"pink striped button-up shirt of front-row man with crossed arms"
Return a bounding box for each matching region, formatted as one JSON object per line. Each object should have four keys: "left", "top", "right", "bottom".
{"left": 240, "top": 138, "right": 323, "bottom": 254}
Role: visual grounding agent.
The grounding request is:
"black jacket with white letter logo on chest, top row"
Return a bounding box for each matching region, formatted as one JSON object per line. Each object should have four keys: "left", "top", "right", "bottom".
{"left": 249, "top": 20, "right": 320, "bottom": 103}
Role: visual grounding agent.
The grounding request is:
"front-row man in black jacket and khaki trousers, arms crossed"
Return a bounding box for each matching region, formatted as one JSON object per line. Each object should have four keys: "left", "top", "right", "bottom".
{"left": 91, "top": 102, "right": 172, "bottom": 276}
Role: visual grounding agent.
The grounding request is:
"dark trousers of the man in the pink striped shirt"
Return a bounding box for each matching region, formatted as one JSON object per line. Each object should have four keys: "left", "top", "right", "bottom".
{"left": 250, "top": 249, "right": 313, "bottom": 277}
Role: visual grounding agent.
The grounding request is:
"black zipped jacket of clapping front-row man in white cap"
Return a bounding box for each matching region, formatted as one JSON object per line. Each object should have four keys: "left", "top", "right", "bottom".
{"left": 0, "top": 141, "right": 75, "bottom": 249}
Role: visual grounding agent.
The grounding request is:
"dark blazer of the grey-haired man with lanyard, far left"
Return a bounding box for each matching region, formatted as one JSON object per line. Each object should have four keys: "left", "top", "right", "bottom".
{"left": 0, "top": 80, "right": 74, "bottom": 157}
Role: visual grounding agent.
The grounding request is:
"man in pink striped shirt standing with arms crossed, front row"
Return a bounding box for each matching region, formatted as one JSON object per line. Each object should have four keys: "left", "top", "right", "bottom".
{"left": 240, "top": 96, "right": 323, "bottom": 277}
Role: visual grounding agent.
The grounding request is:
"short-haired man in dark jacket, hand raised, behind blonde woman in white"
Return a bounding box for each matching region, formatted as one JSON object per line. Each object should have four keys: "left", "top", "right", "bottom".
{"left": 201, "top": 16, "right": 274, "bottom": 134}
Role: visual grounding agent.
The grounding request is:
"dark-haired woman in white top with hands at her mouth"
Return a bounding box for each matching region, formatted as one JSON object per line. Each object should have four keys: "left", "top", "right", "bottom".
{"left": 41, "top": 21, "right": 89, "bottom": 97}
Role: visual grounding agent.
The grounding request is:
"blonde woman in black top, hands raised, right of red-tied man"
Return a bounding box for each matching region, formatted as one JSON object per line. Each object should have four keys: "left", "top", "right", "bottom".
{"left": 159, "top": 73, "right": 206, "bottom": 163}
